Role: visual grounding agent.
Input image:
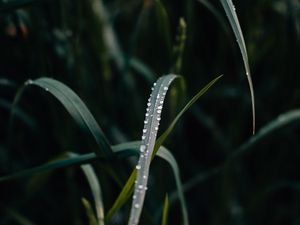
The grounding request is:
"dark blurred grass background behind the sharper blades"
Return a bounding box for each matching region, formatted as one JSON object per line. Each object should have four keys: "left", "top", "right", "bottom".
{"left": 0, "top": 0, "right": 300, "bottom": 225}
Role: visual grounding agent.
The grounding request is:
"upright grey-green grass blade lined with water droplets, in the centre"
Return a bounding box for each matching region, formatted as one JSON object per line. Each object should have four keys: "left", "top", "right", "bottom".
{"left": 128, "top": 75, "right": 177, "bottom": 225}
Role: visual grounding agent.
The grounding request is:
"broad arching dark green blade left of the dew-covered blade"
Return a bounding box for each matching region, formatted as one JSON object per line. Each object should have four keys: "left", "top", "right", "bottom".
{"left": 22, "top": 78, "right": 113, "bottom": 158}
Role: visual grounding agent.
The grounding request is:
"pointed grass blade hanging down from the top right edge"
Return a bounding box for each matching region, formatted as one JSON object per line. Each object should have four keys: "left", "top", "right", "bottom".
{"left": 220, "top": 0, "right": 255, "bottom": 134}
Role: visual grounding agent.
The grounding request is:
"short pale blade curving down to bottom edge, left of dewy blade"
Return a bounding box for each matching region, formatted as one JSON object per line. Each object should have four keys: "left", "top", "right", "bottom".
{"left": 68, "top": 153, "right": 104, "bottom": 225}
